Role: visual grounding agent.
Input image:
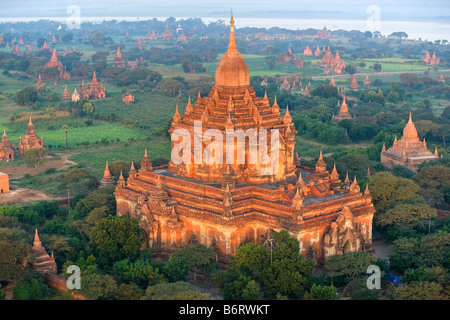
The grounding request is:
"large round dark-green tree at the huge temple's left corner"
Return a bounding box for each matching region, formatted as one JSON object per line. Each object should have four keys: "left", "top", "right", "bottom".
{"left": 91, "top": 216, "right": 145, "bottom": 262}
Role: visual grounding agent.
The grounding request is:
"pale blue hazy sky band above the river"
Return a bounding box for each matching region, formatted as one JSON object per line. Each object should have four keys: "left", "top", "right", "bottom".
{"left": 0, "top": 0, "right": 450, "bottom": 20}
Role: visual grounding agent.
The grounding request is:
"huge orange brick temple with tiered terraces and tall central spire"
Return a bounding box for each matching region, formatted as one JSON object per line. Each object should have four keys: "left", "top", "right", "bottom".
{"left": 115, "top": 17, "right": 374, "bottom": 263}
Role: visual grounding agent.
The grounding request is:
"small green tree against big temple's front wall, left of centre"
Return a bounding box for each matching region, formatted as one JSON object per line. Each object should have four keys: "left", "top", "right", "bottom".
{"left": 174, "top": 243, "right": 217, "bottom": 281}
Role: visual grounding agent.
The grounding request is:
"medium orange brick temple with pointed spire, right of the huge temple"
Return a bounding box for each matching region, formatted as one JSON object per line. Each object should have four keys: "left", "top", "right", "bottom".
{"left": 380, "top": 113, "right": 439, "bottom": 171}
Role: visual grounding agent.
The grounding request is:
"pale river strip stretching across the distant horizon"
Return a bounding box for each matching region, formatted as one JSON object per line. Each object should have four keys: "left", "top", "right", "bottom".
{"left": 0, "top": 17, "right": 450, "bottom": 41}
